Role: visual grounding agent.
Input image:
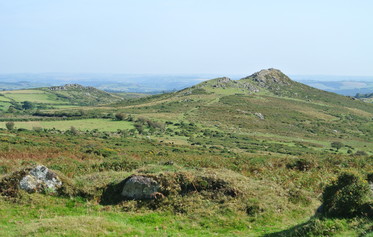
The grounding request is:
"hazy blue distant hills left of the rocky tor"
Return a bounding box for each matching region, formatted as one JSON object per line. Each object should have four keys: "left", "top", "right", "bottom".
{"left": 0, "top": 73, "right": 211, "bottom": 93}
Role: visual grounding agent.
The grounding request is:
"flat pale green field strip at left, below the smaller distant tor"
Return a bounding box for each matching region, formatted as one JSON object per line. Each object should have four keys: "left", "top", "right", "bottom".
{"left": 0, "top": 119, "right": 133, "bottom": 132}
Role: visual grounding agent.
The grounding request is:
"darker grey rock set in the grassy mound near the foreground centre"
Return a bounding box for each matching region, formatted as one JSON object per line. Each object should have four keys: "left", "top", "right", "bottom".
{"left": 121, "top": 175, "right": 159, "bottom": 200}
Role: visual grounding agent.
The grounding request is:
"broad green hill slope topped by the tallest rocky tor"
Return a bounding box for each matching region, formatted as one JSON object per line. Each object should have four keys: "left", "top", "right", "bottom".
{"left": 115, "top": 69, "right": 373, "bottom": 155}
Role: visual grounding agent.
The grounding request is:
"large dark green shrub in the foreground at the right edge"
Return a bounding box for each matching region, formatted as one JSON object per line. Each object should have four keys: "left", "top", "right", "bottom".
{"left": 322, "top": 173, "right": 370, "bottom": 217}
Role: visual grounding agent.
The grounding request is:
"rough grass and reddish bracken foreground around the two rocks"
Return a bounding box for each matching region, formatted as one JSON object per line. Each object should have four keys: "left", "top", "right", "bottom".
{"left": 0, "top": 130, "right": 373, "bottom": 236}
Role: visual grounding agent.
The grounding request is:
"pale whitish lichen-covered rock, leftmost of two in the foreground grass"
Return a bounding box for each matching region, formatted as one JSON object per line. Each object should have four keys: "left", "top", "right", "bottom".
{"left": 19, "top": 165, "right": 62, "bottom": 193}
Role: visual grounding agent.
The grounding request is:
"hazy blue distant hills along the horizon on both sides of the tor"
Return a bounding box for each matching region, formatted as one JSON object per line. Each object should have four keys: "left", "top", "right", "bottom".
{"left": 0, "top": 73, "right": 373, "bottom": 96}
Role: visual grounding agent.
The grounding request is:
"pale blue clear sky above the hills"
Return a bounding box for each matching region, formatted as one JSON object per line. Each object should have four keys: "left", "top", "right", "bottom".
{"left": 0, "top": 0, "right": 373, "bottom": 76}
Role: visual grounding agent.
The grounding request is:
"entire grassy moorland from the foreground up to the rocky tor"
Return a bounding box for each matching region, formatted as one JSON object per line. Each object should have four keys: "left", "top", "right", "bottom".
{"left": 0, "top": 69, "right": 373, "bottom": 236}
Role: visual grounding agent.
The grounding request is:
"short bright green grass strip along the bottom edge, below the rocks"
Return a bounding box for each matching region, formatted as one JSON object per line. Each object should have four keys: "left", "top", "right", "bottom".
{"left": 0, "top": 196, "right": 270, "bottom": 236}
